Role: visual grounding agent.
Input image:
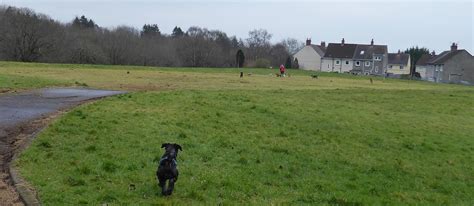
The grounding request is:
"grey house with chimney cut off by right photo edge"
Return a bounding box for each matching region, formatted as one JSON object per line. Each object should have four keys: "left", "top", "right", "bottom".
{"left": 428, "top": 43, "right": 474, "bottom": 84}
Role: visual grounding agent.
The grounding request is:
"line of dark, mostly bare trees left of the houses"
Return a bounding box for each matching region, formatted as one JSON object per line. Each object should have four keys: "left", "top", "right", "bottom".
{"left": 0, "top": 6, "right": 303, "bottom": 67}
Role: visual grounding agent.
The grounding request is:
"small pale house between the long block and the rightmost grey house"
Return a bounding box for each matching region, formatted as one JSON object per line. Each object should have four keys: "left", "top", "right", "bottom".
{"left": 387, "top": 50, "right": 411, "bottom": 76}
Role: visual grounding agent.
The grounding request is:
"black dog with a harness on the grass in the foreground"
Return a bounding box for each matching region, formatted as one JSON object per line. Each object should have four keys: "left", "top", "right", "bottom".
{"left": 156, "top": 143, "right": 182, "bottom": 195}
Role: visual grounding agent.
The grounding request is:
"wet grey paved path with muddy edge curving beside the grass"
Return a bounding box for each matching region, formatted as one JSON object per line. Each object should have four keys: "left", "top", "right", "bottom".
{"left": 0, "top": 88, "right": 124, "bottom": 205}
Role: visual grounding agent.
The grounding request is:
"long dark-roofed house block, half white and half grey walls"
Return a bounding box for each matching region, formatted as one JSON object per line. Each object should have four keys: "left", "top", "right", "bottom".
{"left": 321, "top": 39, "right": 388, "bottom": 75}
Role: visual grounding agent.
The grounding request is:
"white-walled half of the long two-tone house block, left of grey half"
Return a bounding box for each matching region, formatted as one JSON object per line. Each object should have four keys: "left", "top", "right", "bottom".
{"left": 321, "top": 38, "right": 357, "bottom": 73}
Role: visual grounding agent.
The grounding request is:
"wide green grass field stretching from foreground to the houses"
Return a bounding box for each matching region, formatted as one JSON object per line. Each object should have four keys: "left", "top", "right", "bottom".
{"left": 0, "top": 62, "right": 474, "bottom": 205}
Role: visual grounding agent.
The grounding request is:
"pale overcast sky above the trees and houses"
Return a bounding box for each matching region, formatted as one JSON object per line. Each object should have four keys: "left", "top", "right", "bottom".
{"left": 0, "top": 0, "right": 474, "bottom": 54}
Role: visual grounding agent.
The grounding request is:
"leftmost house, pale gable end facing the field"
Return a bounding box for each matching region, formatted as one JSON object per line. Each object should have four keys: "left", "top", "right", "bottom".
{"left": 293, "top": 39, "right": 326, "bottom": 71}
